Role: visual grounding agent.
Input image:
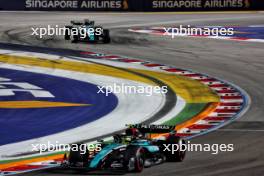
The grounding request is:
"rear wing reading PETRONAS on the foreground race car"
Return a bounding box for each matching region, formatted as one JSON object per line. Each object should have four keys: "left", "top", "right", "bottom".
{"left": 126, "top": 124, "right": 175, "bottom": 133}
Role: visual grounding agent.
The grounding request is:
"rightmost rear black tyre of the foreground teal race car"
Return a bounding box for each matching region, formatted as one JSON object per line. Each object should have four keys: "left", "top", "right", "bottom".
{"left": 164, "top": 135, "right": 186, "bottom": 162}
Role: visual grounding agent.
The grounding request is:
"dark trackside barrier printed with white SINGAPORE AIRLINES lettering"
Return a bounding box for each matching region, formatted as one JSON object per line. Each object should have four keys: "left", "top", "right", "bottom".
{"left": 0, "top": 0, "right": 264, "bottom": 12}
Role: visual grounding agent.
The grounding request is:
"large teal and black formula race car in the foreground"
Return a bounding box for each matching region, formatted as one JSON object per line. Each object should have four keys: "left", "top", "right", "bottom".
{"left": 62, "top": 124, "right": 186, "bottom": 172}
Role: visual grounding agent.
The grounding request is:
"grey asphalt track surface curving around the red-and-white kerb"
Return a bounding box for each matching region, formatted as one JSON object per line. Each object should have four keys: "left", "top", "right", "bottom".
{"left": 0, "top": 12, "right": 264, "bottom": 176}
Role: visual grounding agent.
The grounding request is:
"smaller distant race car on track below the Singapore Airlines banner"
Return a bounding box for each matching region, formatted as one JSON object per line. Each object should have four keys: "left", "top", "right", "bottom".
{"left": 64, "top": 19, "right": 111, "bottom": 43}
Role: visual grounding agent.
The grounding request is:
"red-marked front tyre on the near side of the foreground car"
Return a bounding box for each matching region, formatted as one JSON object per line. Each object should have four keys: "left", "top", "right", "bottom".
{"left": 125, "top": 146, "right": 145, "bottom": 172}
